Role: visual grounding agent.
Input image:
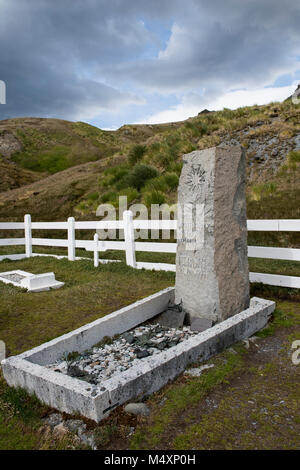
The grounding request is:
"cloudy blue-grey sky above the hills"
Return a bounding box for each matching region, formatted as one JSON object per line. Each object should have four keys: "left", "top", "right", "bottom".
{"left": 0, "top": 0, "right": 300, "bottom": 129}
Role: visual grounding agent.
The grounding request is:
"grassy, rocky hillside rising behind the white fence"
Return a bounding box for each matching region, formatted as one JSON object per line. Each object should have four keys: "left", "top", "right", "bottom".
{"left": 0, "top": 100, "right": 300, "bottom": 239}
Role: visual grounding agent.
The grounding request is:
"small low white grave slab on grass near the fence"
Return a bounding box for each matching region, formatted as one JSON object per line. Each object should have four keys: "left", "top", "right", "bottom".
{"left": 0, "top": 269, "right": 64, "bottom": 292}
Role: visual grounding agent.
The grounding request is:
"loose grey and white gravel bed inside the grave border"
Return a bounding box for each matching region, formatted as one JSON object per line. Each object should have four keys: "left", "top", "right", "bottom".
{"left": 47, "top": 324, "right": 198, "bottom": 390}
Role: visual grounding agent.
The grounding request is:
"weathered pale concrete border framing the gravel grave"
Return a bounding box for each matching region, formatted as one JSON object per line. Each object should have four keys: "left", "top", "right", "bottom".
{"left": 2, "top": 287, "right": 275, "bottom": 422}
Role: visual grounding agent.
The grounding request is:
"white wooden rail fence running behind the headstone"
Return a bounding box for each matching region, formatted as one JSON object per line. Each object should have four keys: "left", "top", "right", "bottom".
{"left": 0, "top": 211, "right": 300, "bottom": 288}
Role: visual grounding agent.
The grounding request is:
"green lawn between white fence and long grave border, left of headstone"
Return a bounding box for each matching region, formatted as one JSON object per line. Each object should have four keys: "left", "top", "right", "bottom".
{"left": 0, "top": 257, "right": 174, "bottom": 355}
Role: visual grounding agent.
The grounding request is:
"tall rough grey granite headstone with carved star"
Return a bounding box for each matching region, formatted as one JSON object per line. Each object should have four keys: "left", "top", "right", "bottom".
{"left": 175, "top": 146, "right": 249, "bottom": 322}
